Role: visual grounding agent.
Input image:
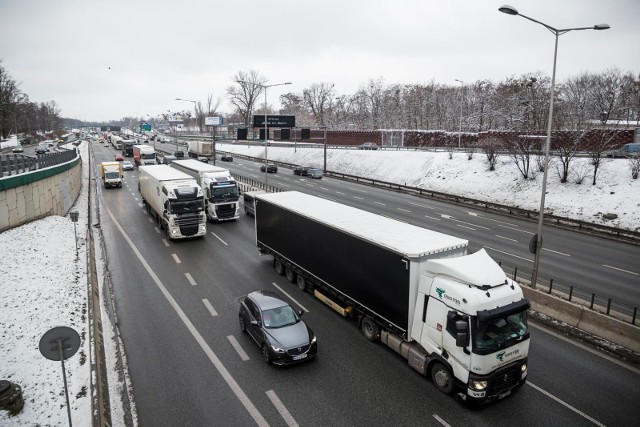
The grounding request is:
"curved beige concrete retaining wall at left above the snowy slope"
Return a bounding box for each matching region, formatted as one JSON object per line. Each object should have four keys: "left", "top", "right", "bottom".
{"left": 0, "top": 156, "right": 82, "bottom": 232}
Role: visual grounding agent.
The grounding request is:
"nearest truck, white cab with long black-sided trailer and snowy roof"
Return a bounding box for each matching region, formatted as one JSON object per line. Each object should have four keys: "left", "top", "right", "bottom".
{"left": 255, "top": 191, "right": 530, "bottom": 402}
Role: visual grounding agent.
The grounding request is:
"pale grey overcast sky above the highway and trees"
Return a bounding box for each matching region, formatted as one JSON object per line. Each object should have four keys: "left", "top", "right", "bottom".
{"left": 0, "top": 0, "right": 640, "bottom": 120}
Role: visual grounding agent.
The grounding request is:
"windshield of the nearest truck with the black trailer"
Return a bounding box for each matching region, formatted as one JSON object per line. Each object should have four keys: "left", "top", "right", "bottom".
{"left": 473, "top": 310, "right": 529, "bottom": 351}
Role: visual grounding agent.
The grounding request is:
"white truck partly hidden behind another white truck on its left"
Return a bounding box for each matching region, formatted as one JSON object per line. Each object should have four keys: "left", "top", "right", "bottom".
{"left": 171, "top": 159, "right": 240, "bottom": 221}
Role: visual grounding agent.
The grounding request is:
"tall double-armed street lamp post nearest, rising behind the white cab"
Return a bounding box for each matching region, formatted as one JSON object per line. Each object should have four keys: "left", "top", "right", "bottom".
{"left": 498, "top": 5, "right": 610, "bottom": 289}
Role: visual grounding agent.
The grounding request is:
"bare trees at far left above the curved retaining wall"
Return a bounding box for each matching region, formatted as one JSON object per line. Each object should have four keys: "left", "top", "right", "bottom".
{"left": 0, "top": 61, "right": 63, "bottom": 139}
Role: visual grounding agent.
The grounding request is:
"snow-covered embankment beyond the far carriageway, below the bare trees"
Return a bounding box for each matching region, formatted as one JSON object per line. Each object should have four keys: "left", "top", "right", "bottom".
{"left": 216, "top": 143, "right": 640, "bottom": 231}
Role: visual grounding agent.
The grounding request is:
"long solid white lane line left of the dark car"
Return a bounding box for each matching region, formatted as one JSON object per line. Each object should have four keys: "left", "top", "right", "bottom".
{"left": 107, "top": 207, "right": 269, "bottom": 427}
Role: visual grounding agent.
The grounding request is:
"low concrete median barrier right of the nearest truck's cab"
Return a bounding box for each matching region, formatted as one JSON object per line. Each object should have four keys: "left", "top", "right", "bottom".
{"left": 522, "top": 286, "right": 640, "bottom": 352}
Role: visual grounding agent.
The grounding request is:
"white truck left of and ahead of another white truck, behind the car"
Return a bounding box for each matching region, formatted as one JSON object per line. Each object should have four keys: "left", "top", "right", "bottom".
{"left": 138, "top": 165, "right": 207, "bottom": 239}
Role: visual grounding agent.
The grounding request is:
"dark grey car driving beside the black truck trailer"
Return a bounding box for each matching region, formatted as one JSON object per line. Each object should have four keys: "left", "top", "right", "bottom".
{"left": 238, "top": 290, "right": 318, "bottom": 365}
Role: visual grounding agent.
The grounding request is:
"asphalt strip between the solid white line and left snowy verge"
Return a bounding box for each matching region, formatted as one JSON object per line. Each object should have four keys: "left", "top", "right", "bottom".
{"left": 98, "top": 198, "right": 262, "bottom": 425}
